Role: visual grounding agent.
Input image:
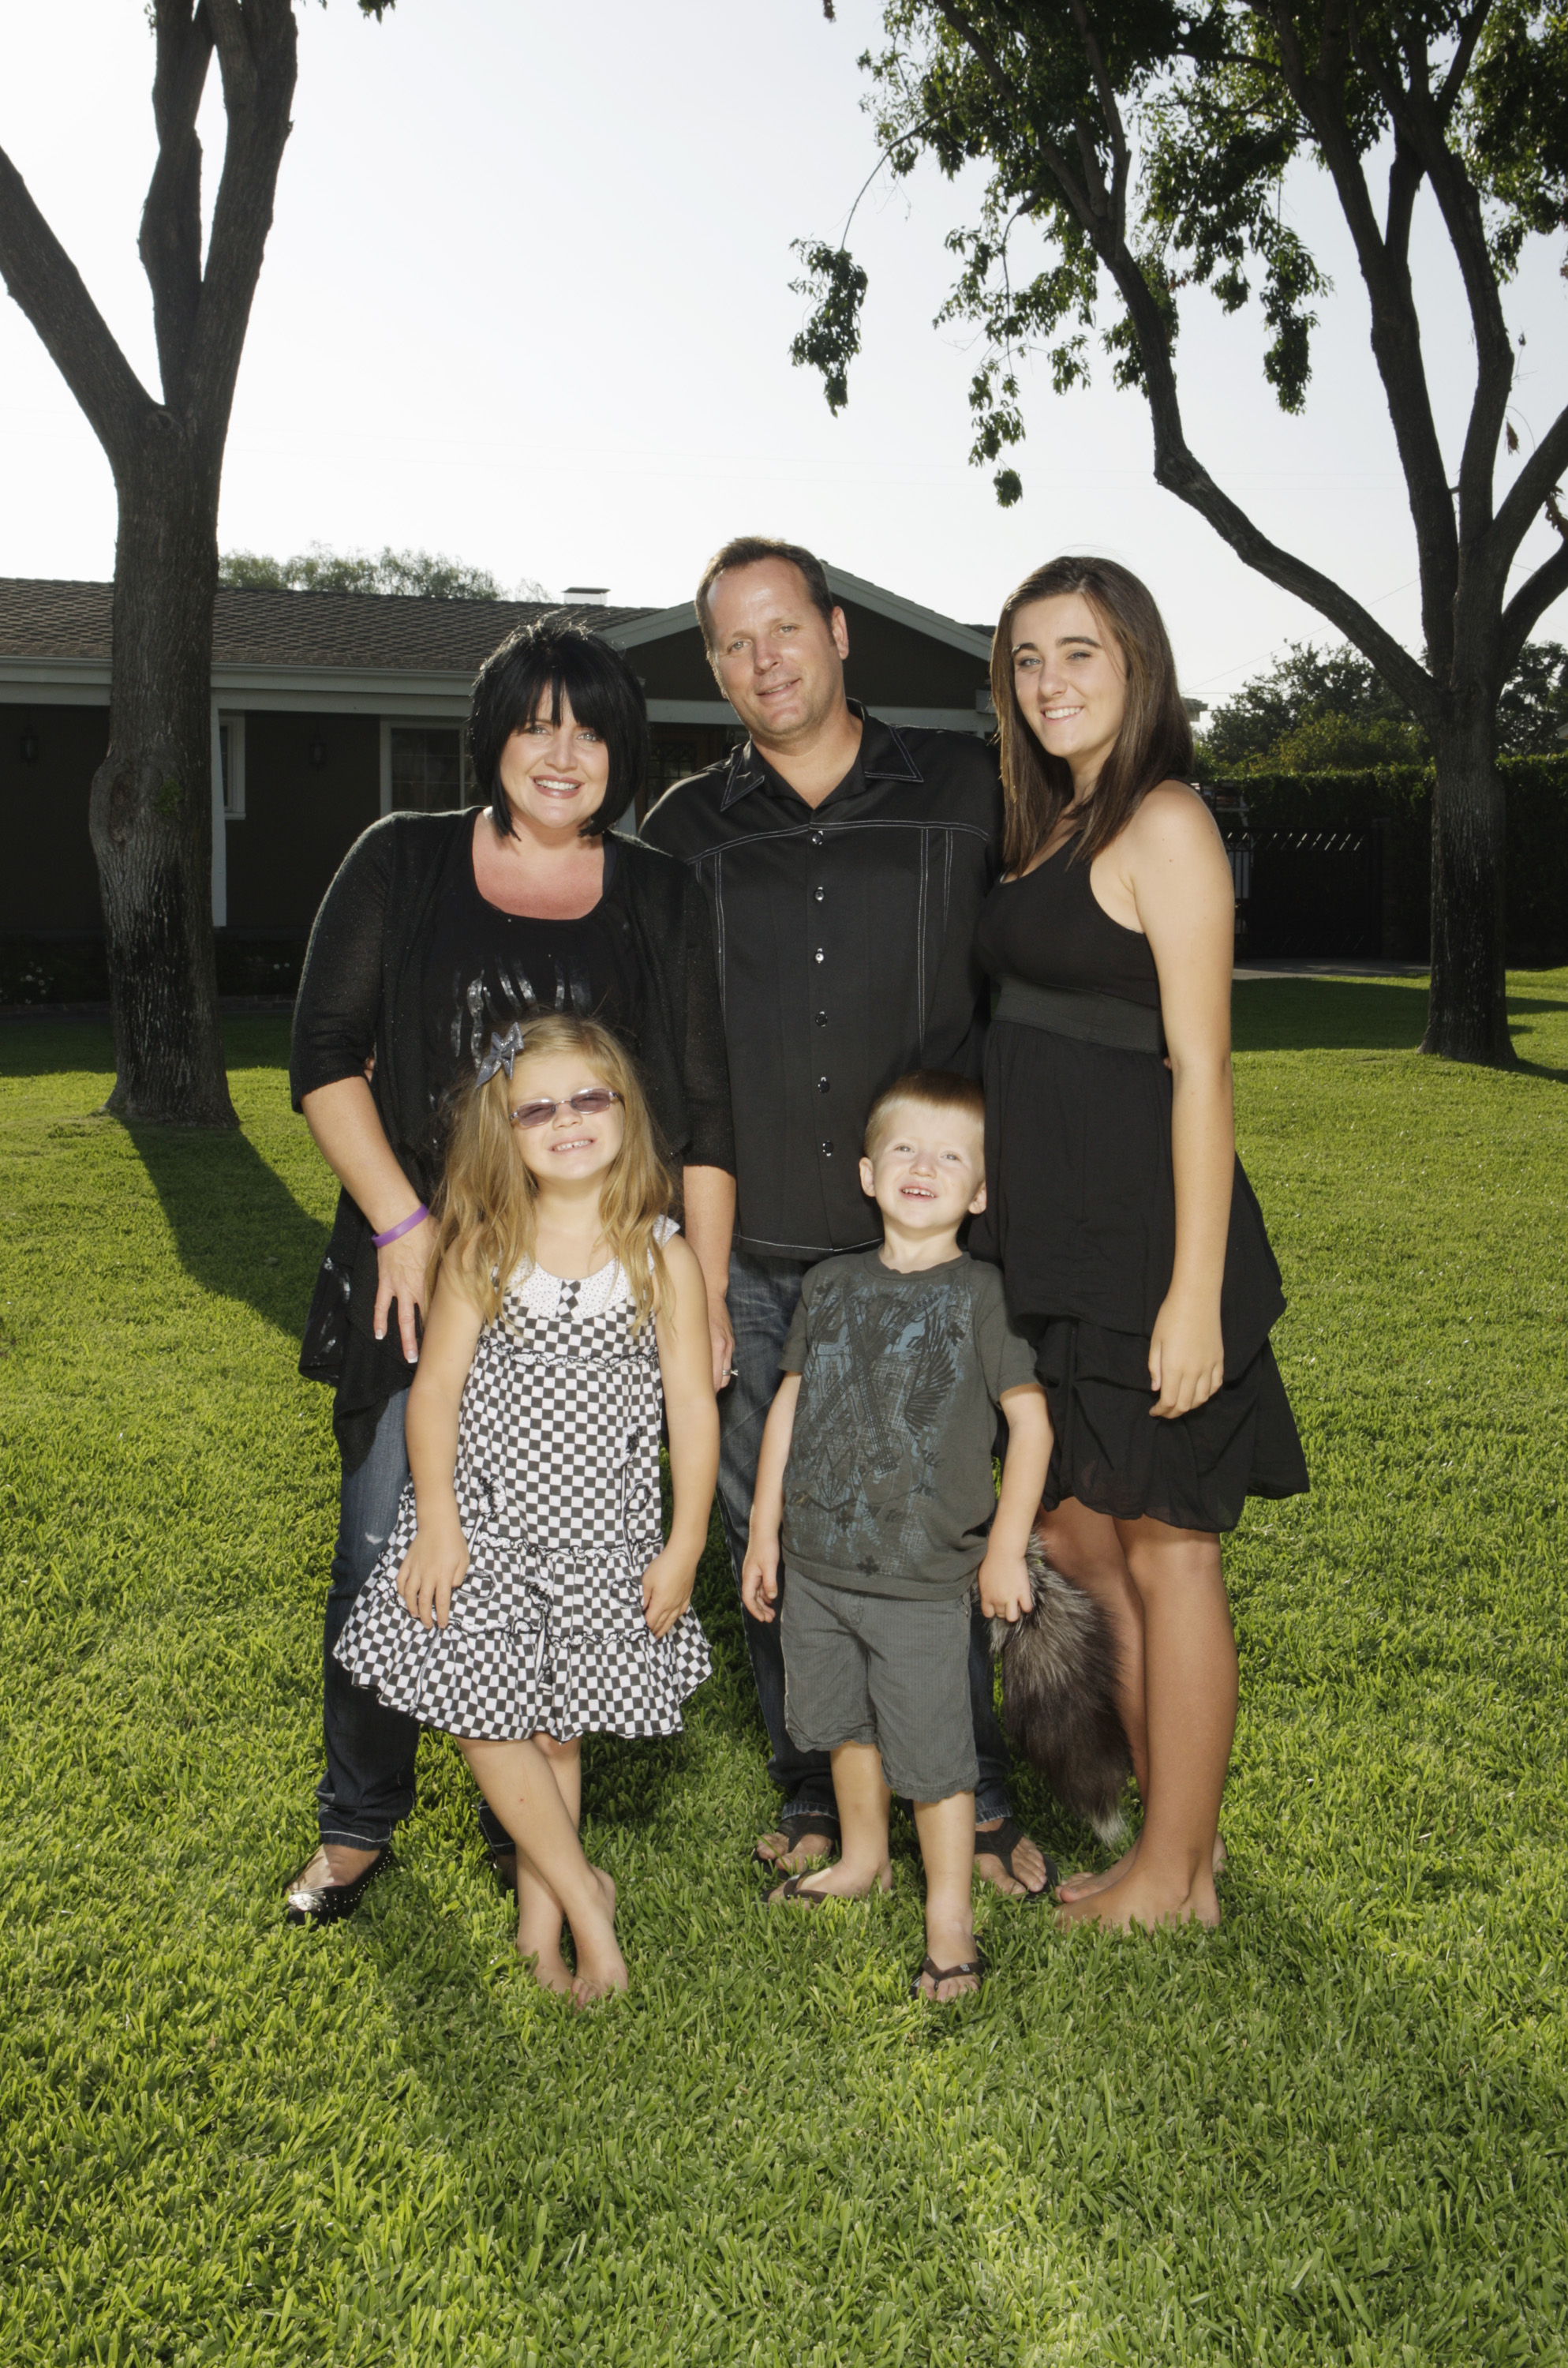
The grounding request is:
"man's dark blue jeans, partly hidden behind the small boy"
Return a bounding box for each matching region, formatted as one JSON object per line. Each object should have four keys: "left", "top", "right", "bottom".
{"left": 717, "top": 1250, "right": 1009, "bottom": 1826}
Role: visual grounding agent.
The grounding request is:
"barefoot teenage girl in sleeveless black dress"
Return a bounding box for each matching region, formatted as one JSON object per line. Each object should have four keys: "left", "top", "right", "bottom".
{"left": 971, "top": 559, "right": 1308, "bottom": 1925}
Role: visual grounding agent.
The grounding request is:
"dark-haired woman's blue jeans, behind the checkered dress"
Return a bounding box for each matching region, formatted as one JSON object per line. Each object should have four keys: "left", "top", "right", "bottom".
{"left": 315, "top": 1390, "right": 509, "bottom": 1849}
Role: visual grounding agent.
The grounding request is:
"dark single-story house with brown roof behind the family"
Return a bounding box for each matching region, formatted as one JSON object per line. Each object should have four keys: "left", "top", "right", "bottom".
{"left": 0, "top": 568, "right": 993, "bottom": 971}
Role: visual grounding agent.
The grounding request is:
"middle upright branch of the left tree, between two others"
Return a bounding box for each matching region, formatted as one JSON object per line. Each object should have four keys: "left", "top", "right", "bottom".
{"left": 137, "top": 0, "right": 213, "bottom": 410}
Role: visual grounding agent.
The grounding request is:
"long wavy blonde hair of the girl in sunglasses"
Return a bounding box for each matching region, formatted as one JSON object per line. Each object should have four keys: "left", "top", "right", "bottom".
{"left": 428, "top": 1014, "right": 675, "bottom": 1331}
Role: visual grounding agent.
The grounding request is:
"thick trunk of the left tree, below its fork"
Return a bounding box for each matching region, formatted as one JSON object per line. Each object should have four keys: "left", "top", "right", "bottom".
{"left": 90, "top": 410, "right": 237, "bottom": 1127}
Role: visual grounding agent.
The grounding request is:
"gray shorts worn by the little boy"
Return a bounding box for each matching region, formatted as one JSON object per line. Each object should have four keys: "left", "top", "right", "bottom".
{"left": 781, "top": 1570, "right": 981, "bottom": 1800}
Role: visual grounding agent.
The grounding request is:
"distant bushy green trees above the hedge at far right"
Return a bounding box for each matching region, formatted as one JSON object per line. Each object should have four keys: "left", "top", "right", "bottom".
{"left": 1199, "top": 642, "right": 1568, "bottom": 774}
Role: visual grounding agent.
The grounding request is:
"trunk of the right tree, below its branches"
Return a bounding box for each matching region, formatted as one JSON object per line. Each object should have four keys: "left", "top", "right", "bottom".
{"left": 1421, "top": 687, "right": 1516, "bottom": 1068}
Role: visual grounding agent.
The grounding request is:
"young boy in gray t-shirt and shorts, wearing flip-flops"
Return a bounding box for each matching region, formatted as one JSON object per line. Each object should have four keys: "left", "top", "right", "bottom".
{"left": 741, "top": 1070, "right": 1052, "bottom": 1999}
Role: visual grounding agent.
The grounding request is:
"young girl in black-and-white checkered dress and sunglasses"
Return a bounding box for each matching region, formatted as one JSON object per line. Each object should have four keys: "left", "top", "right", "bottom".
{"left": 336, "top": 1016, "right": 717, "bottom": 2006}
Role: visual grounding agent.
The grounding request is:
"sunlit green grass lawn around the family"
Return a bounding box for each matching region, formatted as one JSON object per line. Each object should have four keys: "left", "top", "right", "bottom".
{"left": 0, "top": 973, "right": 1568, "bottom": 2368}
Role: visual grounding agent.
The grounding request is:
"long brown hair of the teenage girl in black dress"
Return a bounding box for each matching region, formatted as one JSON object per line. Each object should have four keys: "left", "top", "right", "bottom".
{"left": 990, "top": 559, "right": 1192, "bottom": 874}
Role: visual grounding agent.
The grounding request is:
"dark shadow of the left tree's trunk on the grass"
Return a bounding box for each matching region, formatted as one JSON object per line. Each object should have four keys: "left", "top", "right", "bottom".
{"left": 125, "top": 1127, "right": 327, "bottom": 1340}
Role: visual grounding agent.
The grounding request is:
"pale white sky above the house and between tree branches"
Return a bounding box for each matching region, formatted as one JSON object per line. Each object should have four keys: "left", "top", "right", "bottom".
{"left": 0, "top": 0, "right": 1568, "bottom": 701}
